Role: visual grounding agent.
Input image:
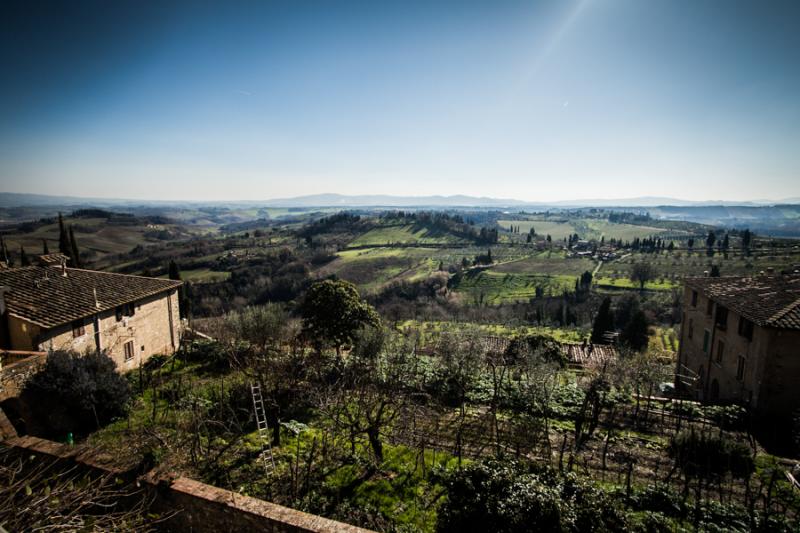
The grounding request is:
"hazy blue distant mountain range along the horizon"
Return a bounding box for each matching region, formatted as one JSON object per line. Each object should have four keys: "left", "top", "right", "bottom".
{"left": 0, "top": 192, "right": 800, "bottom": 209}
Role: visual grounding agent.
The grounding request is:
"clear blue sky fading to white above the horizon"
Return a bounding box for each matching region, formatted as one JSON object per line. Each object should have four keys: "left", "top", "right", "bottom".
{"left": 0, "top": 0, "right": 800, "bottom": 201}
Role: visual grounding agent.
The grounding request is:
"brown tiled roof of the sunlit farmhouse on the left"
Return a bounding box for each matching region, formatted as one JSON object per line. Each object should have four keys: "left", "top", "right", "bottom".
{"left": 0, "top": 266, "right": 181, "bottom": 328}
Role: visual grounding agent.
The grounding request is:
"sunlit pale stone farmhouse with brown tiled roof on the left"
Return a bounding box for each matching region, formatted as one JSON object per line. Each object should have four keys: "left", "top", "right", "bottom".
{"left": 0, "top": 254, "right": 181, "bottom": 370}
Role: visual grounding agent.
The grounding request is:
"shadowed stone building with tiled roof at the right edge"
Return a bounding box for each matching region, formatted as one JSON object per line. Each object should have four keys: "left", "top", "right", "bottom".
{"left": 676, "top": 274, "right": 800, "bottom": 417}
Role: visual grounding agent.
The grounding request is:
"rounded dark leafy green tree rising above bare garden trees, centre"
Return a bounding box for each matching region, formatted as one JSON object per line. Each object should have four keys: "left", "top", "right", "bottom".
{"left": 300, "top": 279, "right": 380, "bottom": 353}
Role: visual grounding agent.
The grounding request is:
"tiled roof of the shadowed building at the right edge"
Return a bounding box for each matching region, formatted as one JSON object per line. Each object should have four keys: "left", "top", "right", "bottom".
{"left": 686, "top": 274, "right": 800, "bottom": 329}
